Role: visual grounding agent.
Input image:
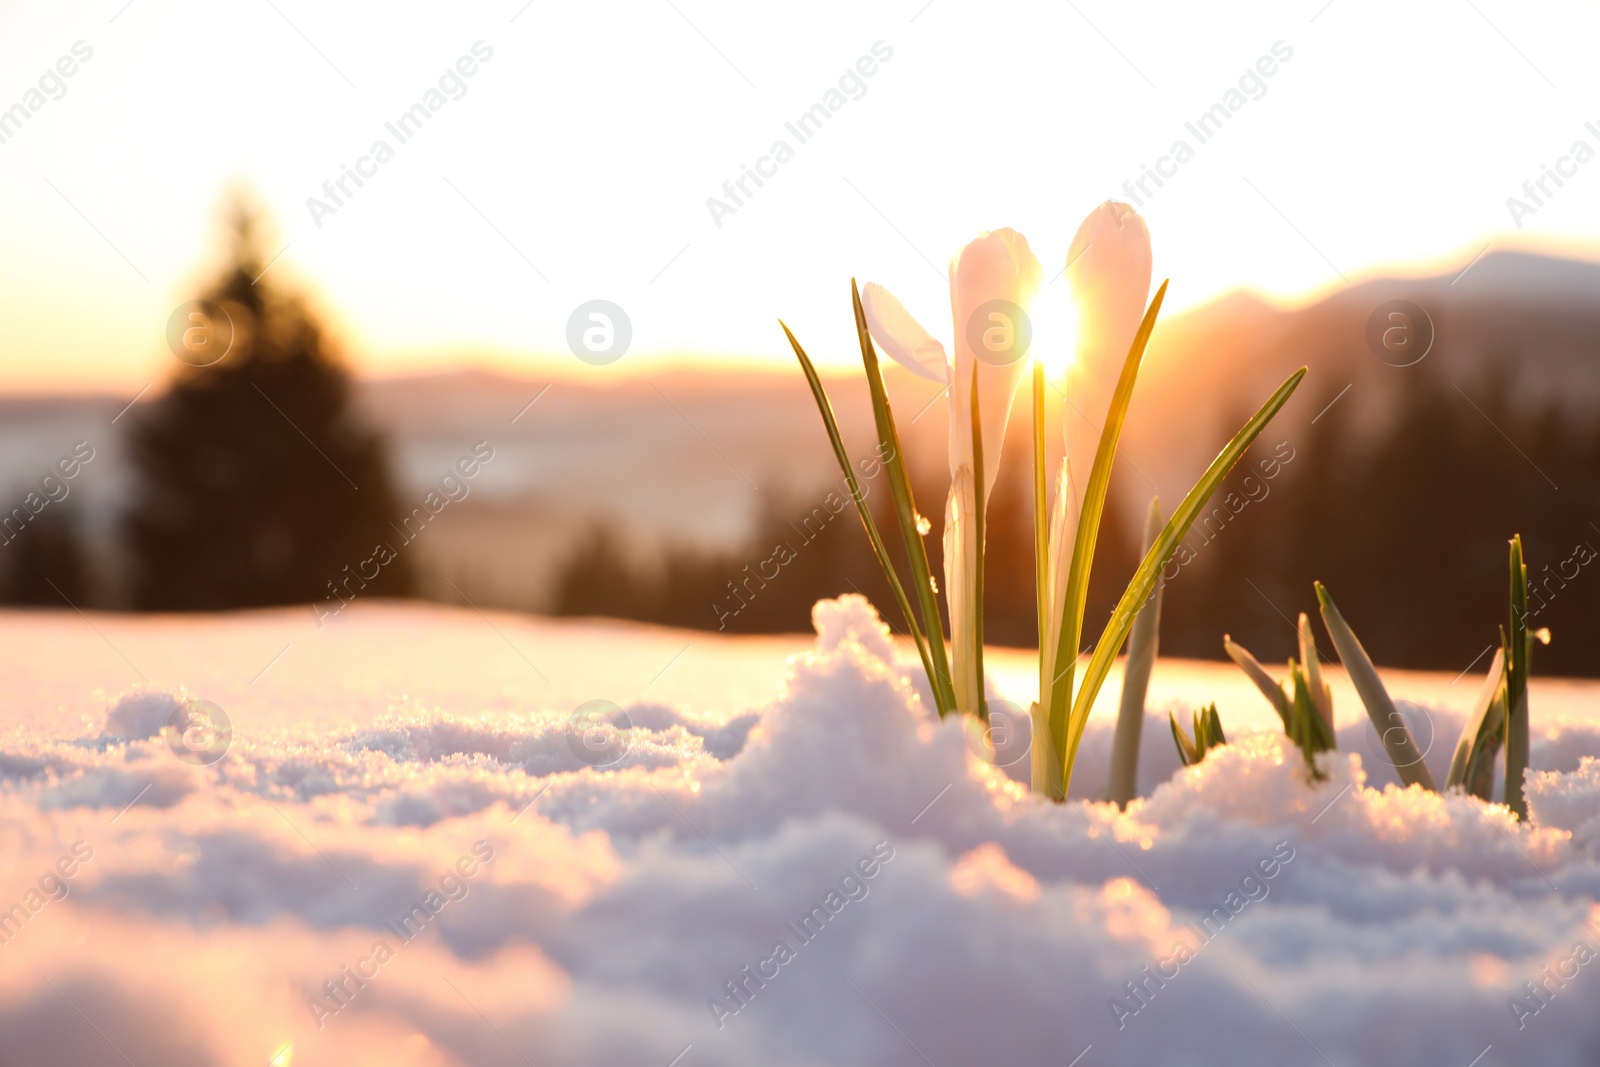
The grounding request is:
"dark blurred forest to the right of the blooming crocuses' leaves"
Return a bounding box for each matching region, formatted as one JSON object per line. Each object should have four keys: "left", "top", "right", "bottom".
{"left": 1162, "top": 369, "right": 1600, "bottom": 675}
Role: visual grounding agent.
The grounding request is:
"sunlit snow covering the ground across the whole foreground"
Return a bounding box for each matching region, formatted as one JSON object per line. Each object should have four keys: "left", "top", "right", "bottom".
{"left": 0, "top": 598, "right": 1600, "bottom": 1067}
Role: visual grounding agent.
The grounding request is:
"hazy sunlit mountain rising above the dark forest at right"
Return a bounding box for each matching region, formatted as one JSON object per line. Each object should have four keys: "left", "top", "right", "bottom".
{"left": 1125, "top": 253, "right": 1600, "bottom": 518}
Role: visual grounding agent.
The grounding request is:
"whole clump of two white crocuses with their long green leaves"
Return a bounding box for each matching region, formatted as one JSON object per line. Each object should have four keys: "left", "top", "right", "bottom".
{"left": 784, "top": 202, "right": 1304, "bottom": 800}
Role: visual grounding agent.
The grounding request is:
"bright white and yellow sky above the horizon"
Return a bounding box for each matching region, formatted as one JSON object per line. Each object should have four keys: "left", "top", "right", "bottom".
{"left": 0, "top": 0, "right": 1600, "bottom": 395}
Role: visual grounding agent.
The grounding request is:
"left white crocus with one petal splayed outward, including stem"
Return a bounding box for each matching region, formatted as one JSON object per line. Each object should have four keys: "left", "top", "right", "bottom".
{"left": 861, "top": 229, "right": 1042, "bottom": 713}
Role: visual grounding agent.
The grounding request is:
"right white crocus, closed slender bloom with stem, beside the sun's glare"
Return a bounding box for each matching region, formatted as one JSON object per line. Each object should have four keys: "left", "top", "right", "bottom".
{"left": 1035, "top": 200, "right": 1150, "bottom": 764}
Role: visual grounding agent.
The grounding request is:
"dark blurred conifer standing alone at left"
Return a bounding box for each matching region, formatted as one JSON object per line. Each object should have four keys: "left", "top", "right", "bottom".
{"left": 125, "top": 202, "right": 414, "bottom": 611}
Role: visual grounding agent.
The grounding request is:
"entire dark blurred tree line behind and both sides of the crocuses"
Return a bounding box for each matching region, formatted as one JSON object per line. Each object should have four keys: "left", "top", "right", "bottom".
{"left": 557, "top": 362, "right": 1600, "bottom": 675}
